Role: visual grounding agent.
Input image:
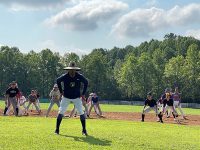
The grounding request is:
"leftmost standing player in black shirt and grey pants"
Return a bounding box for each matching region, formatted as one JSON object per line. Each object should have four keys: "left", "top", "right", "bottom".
{"left": 4, "top": 81, "right": 19, "bottom": 116}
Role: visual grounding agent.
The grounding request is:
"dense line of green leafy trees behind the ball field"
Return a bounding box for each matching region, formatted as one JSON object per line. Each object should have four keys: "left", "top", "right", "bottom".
{"left": 0, "top": 33, "right": 200, "bottom": 102}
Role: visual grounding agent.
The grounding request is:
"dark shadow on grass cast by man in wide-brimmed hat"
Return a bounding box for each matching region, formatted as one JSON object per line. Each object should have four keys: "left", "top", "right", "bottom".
{"left": 60, "top": 134, "right": 111, "bottom": 146}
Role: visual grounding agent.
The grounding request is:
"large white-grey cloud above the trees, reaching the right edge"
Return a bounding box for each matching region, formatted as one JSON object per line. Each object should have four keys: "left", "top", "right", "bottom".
{"left": 112, "top": 4, "right": 200, "bottom": 38}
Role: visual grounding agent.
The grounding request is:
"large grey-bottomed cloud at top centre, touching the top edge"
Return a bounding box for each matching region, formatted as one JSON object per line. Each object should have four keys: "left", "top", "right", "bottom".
{"left": 45, "top": 0, "right": 128, "bottom": 31}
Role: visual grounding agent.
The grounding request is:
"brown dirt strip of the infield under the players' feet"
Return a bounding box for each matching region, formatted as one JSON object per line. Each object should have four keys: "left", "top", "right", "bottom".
{"left": 0, "top": 109, "right": 200, "bottom": 126}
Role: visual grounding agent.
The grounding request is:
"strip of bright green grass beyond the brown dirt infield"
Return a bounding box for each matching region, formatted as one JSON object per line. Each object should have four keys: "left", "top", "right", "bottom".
{"left": 0, "top": 101, "right": 200, "bottom": 115}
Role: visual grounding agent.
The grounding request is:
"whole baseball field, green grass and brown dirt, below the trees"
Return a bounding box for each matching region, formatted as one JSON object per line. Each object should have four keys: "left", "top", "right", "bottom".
{"left": 0, "top": 102, "right": 200, "bottom": 150}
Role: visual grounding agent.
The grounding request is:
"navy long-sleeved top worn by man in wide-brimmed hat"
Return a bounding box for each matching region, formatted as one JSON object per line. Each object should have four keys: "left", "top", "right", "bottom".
{"left": 57, "top": 72, "right": 88, "bottom": 99}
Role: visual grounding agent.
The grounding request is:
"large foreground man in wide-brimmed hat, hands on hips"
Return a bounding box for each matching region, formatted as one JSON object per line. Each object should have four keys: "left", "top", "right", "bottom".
{"left": 55, "top": 62, "right": 88, "bottom": 136}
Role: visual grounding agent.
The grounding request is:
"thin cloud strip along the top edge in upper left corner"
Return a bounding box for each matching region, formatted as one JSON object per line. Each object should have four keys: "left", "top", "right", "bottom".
{"left": 0, "top": 0, "right": 71, "bottom": 11}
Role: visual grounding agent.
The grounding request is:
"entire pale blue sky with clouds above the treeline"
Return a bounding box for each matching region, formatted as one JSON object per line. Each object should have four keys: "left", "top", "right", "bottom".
{"left": 0, "top": 0, "right": 200, "bottom": 55}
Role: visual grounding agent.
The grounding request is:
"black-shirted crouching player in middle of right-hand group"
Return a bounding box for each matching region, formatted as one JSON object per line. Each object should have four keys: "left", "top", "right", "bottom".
{"left": 162, "top": 93, "right": 180, "bottom": 123}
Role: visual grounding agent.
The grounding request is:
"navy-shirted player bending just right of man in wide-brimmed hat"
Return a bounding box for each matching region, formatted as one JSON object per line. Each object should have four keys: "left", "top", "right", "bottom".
{"left": 89, "top": 93, "right": 102, "bottom": 117}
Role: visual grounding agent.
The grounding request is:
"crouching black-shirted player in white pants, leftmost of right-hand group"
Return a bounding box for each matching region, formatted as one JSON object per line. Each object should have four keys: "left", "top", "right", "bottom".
{"left": 141, "top": 93, "right": 163, "bottom": 123}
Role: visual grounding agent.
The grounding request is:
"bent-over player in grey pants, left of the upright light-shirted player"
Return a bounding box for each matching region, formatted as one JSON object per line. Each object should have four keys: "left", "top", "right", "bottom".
{"left": 26, "top": 90, "right": 41, "bottom": 114}
